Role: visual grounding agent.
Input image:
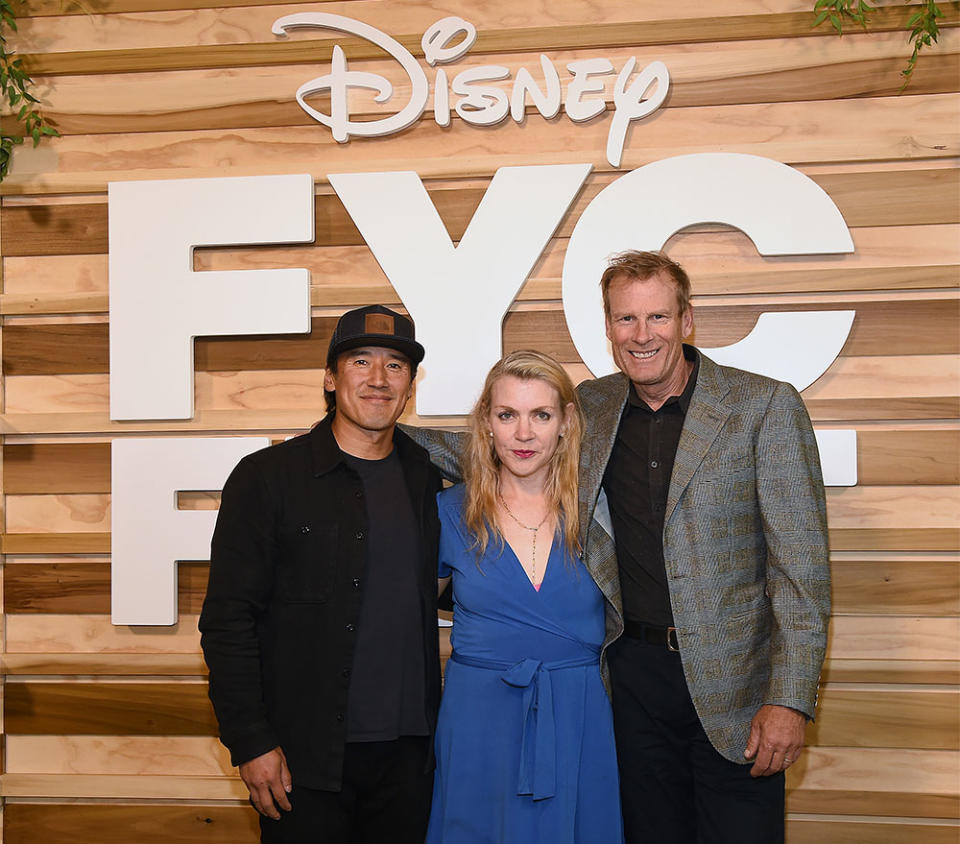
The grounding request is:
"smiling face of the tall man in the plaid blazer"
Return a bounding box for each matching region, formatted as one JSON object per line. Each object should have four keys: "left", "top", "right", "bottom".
{"left": 607, "top": 268, "right": 693, "bottom": 409}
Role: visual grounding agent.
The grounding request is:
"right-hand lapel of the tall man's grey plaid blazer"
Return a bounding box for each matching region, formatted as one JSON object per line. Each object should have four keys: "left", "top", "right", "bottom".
{"left": 664, "top": 352, "right": 730, "bottom": 524}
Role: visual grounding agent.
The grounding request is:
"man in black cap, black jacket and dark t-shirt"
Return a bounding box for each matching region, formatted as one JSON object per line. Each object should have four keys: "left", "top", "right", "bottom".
{"left": 200, "top": 305, "right": 440, "bottom": 844}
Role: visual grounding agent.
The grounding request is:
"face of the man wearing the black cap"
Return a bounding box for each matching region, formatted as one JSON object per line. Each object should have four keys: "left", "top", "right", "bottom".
{"left": 323, "top": 346, "right": 413, "bottom": 452}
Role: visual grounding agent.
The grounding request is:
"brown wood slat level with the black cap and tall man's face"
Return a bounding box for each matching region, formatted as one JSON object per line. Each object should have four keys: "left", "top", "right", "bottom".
{"left": 9, "top": 299, "right": 960, "bottom": 375}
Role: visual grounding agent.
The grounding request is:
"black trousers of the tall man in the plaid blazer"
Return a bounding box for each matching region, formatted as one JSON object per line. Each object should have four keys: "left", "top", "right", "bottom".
{"left": 608, "top": 637, "right": 785, "bottom": 844}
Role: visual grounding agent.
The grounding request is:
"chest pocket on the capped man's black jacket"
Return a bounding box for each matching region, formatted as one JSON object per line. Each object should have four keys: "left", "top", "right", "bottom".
{"left": 277, "top": 524, "right": 337, "bottom": 604}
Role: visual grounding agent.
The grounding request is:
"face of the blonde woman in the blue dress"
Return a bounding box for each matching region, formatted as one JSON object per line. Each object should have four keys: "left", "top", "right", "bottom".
{"left": 488, "top": 375, "right": 572, "bottom": 480}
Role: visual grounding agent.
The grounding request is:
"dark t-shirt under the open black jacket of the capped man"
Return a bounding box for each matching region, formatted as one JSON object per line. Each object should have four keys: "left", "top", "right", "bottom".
{"left": 344, "top": 451, "right": 430, "bottom": 741}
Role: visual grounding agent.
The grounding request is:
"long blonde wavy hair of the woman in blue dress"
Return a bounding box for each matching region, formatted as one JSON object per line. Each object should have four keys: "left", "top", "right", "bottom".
{"left": 461, "top": 349, "right": 583, "bottom": 559}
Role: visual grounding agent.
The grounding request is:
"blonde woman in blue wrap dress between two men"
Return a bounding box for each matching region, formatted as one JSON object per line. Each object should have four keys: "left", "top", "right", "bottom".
{"left": 427, "top": 351, "right": 623, "bottom": 844}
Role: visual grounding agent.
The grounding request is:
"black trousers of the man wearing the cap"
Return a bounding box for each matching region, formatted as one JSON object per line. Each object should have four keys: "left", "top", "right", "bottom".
{"left": 260, "top": 736, "right": 433, "bottom": 844}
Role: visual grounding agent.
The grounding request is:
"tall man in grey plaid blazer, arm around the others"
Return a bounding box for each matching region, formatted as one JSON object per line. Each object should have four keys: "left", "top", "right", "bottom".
{"left": 408, "top": 252, "right": 830, "bottom": 844}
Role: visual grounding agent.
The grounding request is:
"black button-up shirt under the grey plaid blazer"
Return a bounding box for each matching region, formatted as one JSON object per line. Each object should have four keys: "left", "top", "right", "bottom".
{"left": 603, "top": 346, "right": 700, "bottom": 627}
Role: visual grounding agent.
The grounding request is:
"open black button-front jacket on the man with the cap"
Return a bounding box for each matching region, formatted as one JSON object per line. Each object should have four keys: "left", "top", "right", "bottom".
{"left": 200, "top": 416, "right": 441, "bottom": 790}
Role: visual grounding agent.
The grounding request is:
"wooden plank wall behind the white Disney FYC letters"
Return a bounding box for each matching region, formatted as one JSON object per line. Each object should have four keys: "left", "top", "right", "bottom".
{"left": 0, "top": 0, "right": 960, "bottom": 844}
